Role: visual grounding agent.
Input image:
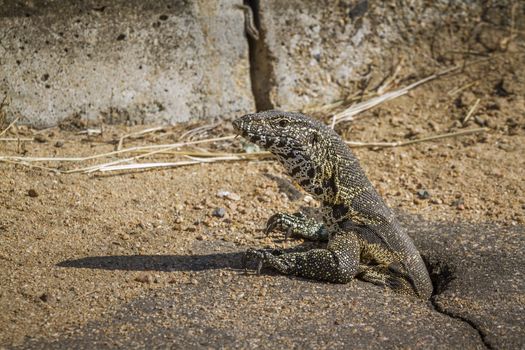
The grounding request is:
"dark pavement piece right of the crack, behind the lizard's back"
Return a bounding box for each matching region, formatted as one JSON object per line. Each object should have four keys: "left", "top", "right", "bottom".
{"left": 408, "top": 219, "right": 525, "bottom": 349}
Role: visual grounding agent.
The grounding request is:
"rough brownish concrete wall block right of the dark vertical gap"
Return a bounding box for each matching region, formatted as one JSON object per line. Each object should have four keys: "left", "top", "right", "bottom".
{"left": 253, "top": 0, "right": 481, "bottom": 110}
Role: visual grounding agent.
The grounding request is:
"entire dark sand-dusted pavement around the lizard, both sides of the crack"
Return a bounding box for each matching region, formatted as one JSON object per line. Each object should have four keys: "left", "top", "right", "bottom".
{"left": 18, "top": 216, "right": 525, "bottom": 349}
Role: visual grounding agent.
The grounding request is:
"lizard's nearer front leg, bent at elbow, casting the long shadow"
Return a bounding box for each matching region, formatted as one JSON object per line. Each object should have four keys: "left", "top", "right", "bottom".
{"left": 245, "top": 232, "right": 361, "bottom": 283}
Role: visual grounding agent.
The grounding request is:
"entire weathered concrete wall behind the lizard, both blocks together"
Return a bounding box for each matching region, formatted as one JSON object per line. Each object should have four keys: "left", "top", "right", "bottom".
{"left": 0, "top": 0, "right": 525, "bottom": 126}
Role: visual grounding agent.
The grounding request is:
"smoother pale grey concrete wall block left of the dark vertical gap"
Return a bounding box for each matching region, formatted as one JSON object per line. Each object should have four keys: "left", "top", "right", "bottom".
{"left": 0, "top": 0, "right": 254, "bottom": 126}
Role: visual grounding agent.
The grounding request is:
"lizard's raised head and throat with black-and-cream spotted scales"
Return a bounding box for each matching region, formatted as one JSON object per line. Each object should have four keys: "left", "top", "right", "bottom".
{"left": 233, "top": 111, "right": 338, "bottom": 195}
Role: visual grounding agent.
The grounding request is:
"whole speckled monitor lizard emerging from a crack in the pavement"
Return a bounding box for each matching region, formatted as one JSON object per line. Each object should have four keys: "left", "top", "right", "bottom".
{"left": 233, "top": 111, "right": 432, "bottom": 299}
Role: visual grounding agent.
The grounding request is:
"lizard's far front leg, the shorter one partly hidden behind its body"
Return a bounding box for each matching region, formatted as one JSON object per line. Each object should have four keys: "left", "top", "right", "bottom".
{"left": 266, "top": 212, "right": 328, "bottom": 242}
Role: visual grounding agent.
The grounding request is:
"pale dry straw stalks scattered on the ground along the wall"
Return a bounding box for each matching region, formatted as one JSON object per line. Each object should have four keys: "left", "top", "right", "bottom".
{"left": 0, "top": 60, "right": 488, "bottom": 174}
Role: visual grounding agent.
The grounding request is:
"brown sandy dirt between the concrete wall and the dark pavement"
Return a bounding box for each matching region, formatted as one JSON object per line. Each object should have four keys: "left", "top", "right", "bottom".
{"left": 0, "top": 47, "right": 525, "bottom": 347}
